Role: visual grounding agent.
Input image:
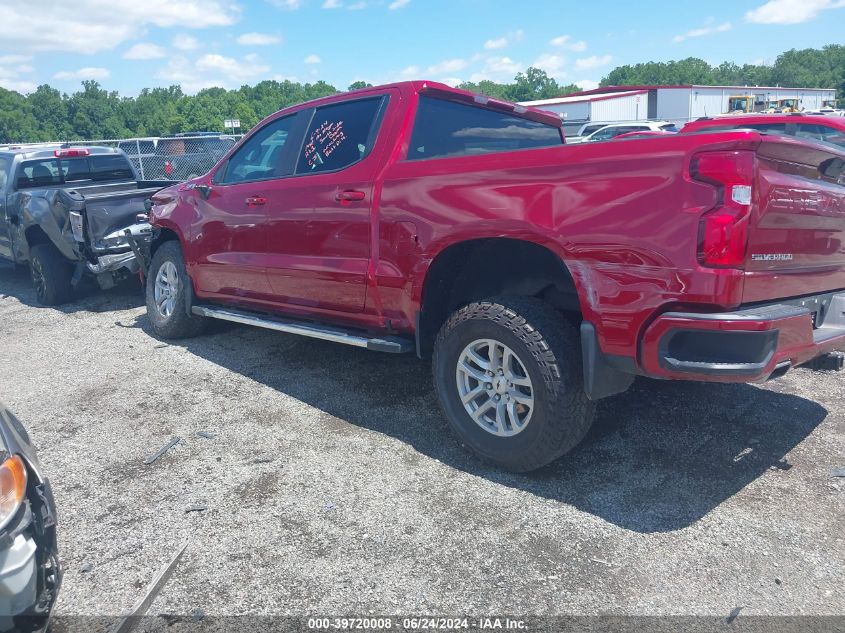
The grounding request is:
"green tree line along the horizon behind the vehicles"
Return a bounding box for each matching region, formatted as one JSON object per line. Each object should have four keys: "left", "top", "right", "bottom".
{"left": 0, "top": 44, "right": 845, "bottom": 143}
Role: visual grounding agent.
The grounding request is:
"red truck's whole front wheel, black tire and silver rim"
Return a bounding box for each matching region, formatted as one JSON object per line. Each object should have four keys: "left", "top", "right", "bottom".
{"left": 146, "top": 241, "right": 206, "bottom": 338}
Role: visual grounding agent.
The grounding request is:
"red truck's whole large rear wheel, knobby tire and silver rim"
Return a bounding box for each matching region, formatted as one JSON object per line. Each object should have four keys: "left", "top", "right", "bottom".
{"left": 433, "top": 297, "right": 595, "bottom": 472}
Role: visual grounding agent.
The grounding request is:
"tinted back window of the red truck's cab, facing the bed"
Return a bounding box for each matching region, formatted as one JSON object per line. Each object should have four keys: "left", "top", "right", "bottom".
{"left": 408, "top": 96, "right": 563, "bottom": 160}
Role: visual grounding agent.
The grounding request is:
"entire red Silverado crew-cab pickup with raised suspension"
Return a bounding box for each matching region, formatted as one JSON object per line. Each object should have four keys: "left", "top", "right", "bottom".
{"left": 146, "top": 82, "right": 845, "bottom": 471}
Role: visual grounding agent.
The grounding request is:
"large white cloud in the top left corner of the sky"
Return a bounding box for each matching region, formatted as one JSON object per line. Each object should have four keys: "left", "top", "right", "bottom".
{"left": 0, "top": 0, "right": 241, "bottom": 54}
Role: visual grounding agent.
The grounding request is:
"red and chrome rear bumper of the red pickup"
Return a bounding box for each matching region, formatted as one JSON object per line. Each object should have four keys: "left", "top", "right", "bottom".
{"left": 640, "top": 292, "right": 845, "bottom": 382}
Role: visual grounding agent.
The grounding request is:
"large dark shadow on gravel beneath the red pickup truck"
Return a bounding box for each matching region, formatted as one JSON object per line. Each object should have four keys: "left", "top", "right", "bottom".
{"left": 165, "top": 316, "right": 827, "bottom": 532}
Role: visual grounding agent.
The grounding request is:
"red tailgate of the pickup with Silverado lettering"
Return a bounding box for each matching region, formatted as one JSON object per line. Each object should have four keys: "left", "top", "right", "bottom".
{"left": 743, "top": 136, "right": 845, "bottom": 303}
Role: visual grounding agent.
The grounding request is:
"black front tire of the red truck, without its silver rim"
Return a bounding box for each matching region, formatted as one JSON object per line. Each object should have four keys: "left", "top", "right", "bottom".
{"left": 145, "top": 241, "right": 207, "bottom": 339}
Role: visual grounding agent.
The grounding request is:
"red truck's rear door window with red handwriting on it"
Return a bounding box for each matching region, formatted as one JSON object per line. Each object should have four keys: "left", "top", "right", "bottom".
{"left": 296, "top": 96, "right": 387, "bottom": 175}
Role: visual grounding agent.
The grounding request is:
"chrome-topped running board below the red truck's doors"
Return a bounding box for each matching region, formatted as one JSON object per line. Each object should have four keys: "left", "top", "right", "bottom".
{"left": 191, "top": 305, "right": 414, "bottom": 354}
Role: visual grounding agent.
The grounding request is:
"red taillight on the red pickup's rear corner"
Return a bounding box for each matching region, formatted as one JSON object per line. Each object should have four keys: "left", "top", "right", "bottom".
{"left": 690, "top": 151, "right": 755, "bottom": 267}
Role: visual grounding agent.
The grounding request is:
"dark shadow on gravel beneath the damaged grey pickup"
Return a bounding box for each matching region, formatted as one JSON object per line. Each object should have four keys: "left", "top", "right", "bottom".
{"left": 0, "top": 266, "right": 144, "bottom": 314}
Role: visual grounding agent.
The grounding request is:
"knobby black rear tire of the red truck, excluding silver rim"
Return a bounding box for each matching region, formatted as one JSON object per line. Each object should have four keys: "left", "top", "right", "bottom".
{"left": 433, "top": 297, "right": 595, "bottom": 472}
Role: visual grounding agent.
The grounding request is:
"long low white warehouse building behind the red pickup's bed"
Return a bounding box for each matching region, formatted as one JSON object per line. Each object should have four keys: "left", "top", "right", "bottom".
{"left": 521, "top": 86, "right": 836, "bottom": 127}
